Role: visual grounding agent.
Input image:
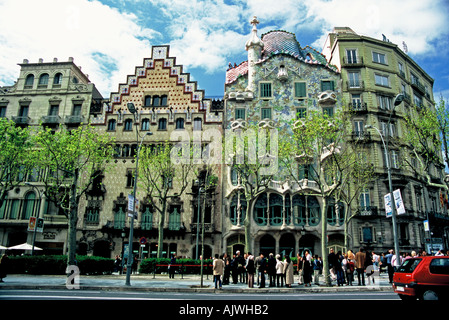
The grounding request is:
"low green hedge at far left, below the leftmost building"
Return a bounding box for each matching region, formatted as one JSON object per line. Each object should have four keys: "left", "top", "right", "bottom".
{"left": 9, "top": 255, "right": 114, "bottom": 275}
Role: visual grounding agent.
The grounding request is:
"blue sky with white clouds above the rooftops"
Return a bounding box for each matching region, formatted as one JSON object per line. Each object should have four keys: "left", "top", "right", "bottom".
{"left": 0, "top": 0, "right": 449, "bottom": 101}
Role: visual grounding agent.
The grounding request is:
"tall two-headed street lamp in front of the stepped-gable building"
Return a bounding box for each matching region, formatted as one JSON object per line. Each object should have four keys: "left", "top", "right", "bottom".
{"left": 125, "top": 103, "right": 153, "bottom": 286}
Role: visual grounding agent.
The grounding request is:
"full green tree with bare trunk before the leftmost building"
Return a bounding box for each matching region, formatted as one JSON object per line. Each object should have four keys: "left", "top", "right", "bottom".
{"left": 34, "top": 125, "right": 113, "bottom": 266}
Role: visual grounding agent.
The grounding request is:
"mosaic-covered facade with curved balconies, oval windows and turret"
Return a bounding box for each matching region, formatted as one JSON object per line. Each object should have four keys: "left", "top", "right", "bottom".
{"left": 223, "top": 17, "right": 343, "bottom": 256}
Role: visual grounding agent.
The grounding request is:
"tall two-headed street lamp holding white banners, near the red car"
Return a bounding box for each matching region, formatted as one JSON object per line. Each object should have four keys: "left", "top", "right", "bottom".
{"left": 365, "top": 93, "right": 404, "bottom": 263}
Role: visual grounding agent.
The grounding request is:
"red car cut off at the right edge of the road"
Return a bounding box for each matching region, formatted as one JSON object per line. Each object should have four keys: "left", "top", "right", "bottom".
{"left": 393, "top": 256, "right": 449, "bottom": 300}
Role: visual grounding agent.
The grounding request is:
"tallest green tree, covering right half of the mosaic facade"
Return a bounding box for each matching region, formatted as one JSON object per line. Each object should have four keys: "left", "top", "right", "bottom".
{"left": 280, "top": 110, "right": 354, "bottom": 286}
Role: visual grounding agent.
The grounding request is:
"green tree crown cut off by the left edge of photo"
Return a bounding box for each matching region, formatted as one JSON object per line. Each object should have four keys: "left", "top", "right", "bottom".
{"left": 0, "top": 118, "right": 35, "bottom": 208}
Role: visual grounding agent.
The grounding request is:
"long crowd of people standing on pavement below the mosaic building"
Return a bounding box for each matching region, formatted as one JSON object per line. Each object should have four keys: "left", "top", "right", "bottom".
{"left": 213, "top": 248, "right": 449, "bottom": 289}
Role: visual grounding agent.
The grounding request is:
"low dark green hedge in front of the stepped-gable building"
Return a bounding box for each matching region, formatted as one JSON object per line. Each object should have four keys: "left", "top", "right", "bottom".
{"left": 139, "top": 258, "right": 212, "bottom": 274}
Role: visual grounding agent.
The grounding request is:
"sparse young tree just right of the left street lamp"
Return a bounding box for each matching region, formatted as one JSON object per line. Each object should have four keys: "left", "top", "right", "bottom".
{"left": 139, "top": 139, "right": 193, "bottom": 258}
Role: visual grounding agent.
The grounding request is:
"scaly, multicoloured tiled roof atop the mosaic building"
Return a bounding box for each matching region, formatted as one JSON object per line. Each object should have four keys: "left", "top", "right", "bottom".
{"left": 226, "top": 30, "right": 339, "bottom": 84}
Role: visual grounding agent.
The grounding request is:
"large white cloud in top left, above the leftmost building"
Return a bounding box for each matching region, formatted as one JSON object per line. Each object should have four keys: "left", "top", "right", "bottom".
{"left": 0, "top": 0, "right": 157, "bottom": 97}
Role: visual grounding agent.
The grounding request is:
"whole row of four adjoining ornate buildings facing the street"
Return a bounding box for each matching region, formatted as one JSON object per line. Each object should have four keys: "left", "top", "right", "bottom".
{"left": 0, "top": 18, "right": 449, "bottom": 258}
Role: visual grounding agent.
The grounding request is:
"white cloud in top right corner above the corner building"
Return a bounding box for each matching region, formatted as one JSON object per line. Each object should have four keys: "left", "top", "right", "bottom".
{"left": 300, "top": 0, "right": 448, "bottom": 54}
